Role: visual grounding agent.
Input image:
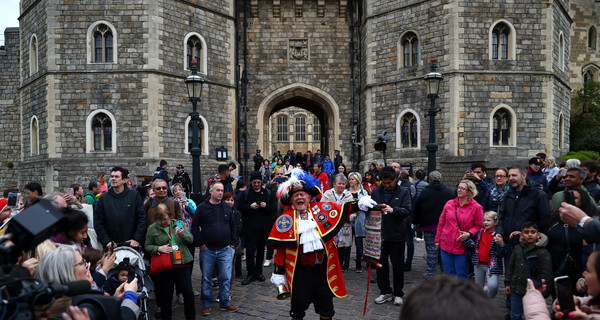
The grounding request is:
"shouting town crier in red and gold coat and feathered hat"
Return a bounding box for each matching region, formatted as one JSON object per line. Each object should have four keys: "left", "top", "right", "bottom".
{"left": 267, "top": 169, "right": 376, "bottom": 319}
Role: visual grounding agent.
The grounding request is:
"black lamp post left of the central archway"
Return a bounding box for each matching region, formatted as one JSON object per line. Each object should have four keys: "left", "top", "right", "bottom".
{"left": 185, "top": 62, "right": 204, "bottom": 203}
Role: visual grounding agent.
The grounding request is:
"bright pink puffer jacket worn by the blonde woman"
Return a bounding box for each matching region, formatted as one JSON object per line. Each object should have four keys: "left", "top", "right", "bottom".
{"left": 435, "top": 198, "right": 483, "bottom": 254}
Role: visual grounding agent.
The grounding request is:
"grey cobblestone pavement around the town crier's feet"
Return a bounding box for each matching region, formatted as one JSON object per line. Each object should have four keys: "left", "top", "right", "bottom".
{"left": 150, "top": 241, "right": 504, "bottom": 320}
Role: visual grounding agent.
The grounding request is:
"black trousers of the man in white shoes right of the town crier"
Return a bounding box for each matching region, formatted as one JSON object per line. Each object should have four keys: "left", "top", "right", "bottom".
{"left": 377, "top": 241, "right": 404, "bottom": 297}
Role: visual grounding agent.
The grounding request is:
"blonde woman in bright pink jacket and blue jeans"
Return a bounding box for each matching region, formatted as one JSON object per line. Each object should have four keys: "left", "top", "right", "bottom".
{"left": 435, "top": 180, "right": 483, "bottom": 280}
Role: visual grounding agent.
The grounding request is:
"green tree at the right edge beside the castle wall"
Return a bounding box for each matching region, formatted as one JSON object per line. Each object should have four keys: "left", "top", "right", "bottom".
{"left": 570, "top": 81, "right": 600, "bottom": 152}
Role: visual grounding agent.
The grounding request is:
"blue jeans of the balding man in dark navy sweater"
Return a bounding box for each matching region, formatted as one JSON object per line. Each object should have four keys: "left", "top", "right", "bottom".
{"left": 199, "top": 246, "right": 234, "bottom": 308}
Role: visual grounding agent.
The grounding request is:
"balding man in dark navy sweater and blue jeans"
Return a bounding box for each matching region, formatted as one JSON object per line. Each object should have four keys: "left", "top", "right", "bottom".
{"left": 192, "top": 181, "right": 238, "bottom": 316}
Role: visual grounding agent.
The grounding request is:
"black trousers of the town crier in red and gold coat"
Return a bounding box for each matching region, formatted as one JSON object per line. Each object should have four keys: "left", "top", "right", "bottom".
{"left": 290, "top": 264, "right": 335, "bottom": 319}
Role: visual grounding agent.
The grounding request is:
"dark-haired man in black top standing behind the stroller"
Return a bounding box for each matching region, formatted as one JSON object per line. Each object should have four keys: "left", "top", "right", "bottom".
{"left": 94, "top": 167, "right": 146, "bottom": 247}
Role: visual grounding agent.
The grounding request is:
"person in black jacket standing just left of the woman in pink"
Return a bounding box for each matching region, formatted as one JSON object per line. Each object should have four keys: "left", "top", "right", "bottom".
{"left": 413, "top": 171, "right": 454, "bottom": 279}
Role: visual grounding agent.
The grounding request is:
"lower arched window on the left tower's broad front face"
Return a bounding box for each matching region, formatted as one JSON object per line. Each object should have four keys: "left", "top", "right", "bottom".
{"left": 85, "top": 109, "right": 117, "bottom": 153}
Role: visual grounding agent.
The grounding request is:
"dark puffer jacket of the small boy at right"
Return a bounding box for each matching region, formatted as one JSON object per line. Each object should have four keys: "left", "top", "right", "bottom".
{"left": 504, "top": 233, "right": 552, "bottom": 297}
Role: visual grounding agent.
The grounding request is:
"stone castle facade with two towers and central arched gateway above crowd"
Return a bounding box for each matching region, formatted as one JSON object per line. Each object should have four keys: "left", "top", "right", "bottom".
{"left": 0, "top": 0, "right": 598, "bottom": 192}
